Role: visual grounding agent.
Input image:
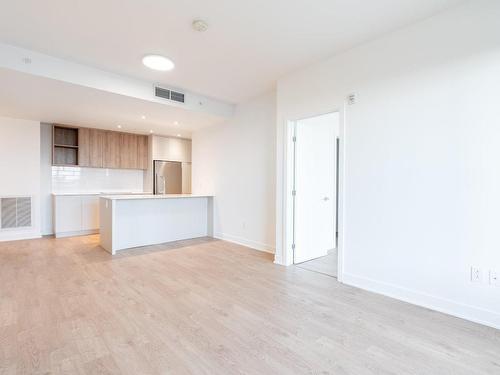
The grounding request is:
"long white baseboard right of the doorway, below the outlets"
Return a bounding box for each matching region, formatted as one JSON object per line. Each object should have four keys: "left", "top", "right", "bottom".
{"left": 342, "top": 273, "right": 500, "bottom": 329}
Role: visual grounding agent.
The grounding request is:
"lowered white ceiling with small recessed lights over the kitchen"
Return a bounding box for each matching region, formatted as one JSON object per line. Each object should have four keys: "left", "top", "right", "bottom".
{"left": 0, "top": 69, "right": 223, "bottom": 138}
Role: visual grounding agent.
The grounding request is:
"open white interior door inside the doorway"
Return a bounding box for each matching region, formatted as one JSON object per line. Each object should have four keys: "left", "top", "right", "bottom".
{"left": 294, "top": 112, "right": 339, "bottom": 263}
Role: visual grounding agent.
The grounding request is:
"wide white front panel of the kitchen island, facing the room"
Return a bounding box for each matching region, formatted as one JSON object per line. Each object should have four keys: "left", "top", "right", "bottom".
{"left": 113, "top": 197, "right": 209, "bottom": 250}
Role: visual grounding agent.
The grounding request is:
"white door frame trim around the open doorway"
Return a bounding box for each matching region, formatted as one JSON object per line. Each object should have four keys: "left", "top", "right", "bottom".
{"left": 282, "top": 108, "right": 346, "bottom": 282}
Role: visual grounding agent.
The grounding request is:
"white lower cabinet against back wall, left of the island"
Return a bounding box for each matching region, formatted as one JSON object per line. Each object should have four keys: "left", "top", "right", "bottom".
{"left": 53, "top": 195, "right": 99, "bottom": 237}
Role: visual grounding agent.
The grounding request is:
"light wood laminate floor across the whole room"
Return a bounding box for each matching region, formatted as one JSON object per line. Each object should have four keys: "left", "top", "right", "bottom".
{"left": 0, "top": 236, "right": 500, "bottom": 375}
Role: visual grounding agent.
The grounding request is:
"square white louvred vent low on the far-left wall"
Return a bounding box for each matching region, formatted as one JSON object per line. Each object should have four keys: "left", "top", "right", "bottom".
{"left": 0, "top": 197, "right": 31, "bottom": 229}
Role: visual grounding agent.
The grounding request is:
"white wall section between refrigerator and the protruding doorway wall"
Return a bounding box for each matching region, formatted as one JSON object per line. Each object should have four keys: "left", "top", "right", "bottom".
{"left": 192, "top": 92, "right": 276, "bottom": 252}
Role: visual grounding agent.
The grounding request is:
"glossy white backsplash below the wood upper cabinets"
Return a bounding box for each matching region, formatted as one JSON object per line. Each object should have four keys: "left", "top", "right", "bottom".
{"left": 52, "top": 167, "right": 144, "bottom": 193}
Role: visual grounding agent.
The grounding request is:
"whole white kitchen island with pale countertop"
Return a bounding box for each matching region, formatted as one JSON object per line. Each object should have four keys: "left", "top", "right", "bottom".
{"left": 99, "top": 194, "right": 213, "bottom": 254}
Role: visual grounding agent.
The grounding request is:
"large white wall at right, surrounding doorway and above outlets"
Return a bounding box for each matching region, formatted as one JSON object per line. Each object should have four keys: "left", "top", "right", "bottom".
{"left": 277, "top": 1, "right": 500, "bottom": 328}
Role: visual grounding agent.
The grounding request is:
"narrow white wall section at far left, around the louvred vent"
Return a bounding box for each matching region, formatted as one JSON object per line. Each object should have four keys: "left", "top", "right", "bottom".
{"left": 0, "top": 117, "right": 40, "bottom": 241}
